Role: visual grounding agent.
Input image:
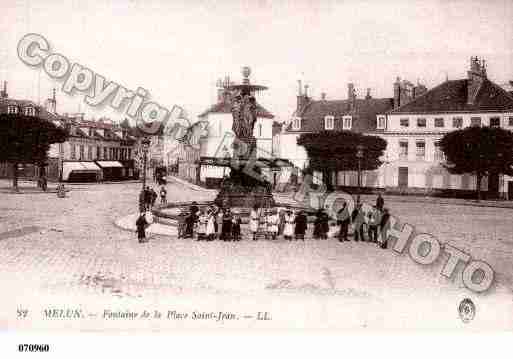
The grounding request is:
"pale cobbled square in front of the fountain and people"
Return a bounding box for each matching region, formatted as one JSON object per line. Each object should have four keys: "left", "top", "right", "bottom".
{"left": 0, "top": 183, "right": 513, "bottom": 330}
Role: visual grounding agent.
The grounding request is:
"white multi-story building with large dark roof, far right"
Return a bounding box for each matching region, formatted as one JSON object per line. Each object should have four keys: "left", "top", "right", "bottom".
{"left": 376, "top": 57, "right": 513, "bottom": 198}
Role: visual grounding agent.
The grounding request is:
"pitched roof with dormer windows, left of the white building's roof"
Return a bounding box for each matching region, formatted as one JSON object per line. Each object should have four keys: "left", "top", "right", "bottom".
{"left": 286, "top": 98, "right": 394, "bottom": 132}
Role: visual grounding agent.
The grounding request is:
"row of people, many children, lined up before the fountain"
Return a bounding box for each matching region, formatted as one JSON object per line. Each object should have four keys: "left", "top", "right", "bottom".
{"left": 174, "top": 196, "right": 390, "bottom": 248}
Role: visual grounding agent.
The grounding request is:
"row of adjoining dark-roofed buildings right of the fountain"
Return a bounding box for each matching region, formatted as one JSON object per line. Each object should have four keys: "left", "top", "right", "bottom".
{"left": 279, "top": 58, "right": 513, "bottom": 198}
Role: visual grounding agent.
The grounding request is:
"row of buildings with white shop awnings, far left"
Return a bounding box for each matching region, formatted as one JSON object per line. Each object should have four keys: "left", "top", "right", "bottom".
{"left": 0, "top": 85, "right": 137, "bottom": 181}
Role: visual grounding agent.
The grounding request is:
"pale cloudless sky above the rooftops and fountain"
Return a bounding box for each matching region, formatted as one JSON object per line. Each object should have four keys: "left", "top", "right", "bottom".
{"left": 0, "top": 0, "right": 513, "bottom": 121}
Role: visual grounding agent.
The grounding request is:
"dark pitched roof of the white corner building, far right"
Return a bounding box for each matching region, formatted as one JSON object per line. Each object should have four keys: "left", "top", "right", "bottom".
{"left": 390, "top": 79, "right": 513, "bottom": 114}
